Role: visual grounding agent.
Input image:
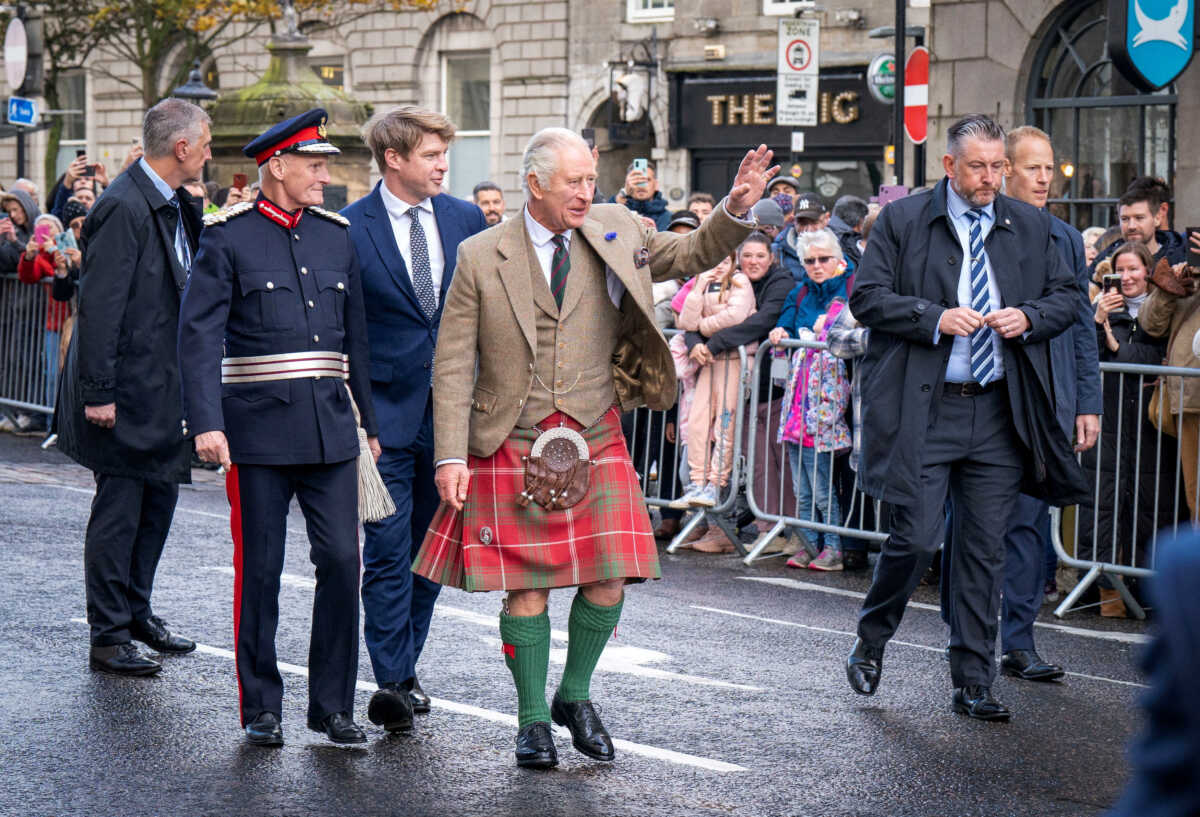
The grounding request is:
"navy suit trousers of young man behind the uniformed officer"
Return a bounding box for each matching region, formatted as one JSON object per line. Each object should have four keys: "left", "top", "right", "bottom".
{"left": 362, "top": 401, "right": 442, "bottom": 684}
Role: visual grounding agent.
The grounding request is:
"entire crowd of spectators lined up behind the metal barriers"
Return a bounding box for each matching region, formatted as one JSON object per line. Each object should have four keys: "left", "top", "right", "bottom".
{"left": 0, "top": 130, "right": 1200, "bottom": 614}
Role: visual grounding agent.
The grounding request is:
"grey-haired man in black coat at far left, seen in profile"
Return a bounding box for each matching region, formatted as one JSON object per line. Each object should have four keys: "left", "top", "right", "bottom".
{"left": 55, "top": 100, "right": 211, "bottom": 675}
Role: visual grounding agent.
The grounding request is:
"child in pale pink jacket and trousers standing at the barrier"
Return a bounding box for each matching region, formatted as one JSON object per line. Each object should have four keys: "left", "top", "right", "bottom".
{"left": 672, "top": 251, "right": 755, "bottom": 518}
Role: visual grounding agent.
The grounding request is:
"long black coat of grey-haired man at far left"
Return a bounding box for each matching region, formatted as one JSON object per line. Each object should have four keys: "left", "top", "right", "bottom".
{"left": 55, "top": 163, "right": 202, "bottom": 482}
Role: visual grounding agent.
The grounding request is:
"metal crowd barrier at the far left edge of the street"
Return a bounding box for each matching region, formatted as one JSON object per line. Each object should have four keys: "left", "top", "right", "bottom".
{"left": 0, "top": 275, "right": 58, "bottom": 414}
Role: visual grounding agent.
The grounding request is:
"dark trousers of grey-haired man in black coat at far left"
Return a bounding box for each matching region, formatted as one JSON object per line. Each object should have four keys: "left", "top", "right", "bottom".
{"left": 83, "top": 474, "right": 179, "bottom": 647}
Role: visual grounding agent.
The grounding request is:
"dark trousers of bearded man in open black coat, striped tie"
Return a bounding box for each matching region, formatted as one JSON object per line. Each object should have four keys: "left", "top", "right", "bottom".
{"left": 858, "top": 386, "right": 1022, "bottom": 687}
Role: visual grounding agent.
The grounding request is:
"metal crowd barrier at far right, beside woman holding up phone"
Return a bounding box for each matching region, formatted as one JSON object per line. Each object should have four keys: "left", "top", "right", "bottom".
{"left": 1050, "top": 362, "right": 1200, "bottom": 619}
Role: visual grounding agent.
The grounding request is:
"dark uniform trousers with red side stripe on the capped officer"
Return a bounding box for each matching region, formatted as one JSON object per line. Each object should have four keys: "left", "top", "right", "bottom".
{"left": 226, "top": 459, "right": 359, "bottom": 726}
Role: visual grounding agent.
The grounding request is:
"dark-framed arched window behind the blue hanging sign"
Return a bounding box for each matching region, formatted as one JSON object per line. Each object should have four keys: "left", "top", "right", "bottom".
{"left": 1026, "top": 0, "right": 1176, "bottom": 229}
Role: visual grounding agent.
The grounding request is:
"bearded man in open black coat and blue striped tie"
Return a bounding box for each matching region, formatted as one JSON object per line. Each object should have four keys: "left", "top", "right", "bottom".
{"left": 846, "top": 115, "right": 1086, "bottom": 720}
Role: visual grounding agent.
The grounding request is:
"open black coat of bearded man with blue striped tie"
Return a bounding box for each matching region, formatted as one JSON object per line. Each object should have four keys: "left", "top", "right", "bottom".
{"left": 850, "top": 179, "right": 1086, "bottom": 504}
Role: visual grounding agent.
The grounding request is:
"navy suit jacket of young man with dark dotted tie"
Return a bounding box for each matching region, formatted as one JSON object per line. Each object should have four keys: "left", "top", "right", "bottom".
{"left": 342, "top": 182, "right": 487, "bottom": 449}
